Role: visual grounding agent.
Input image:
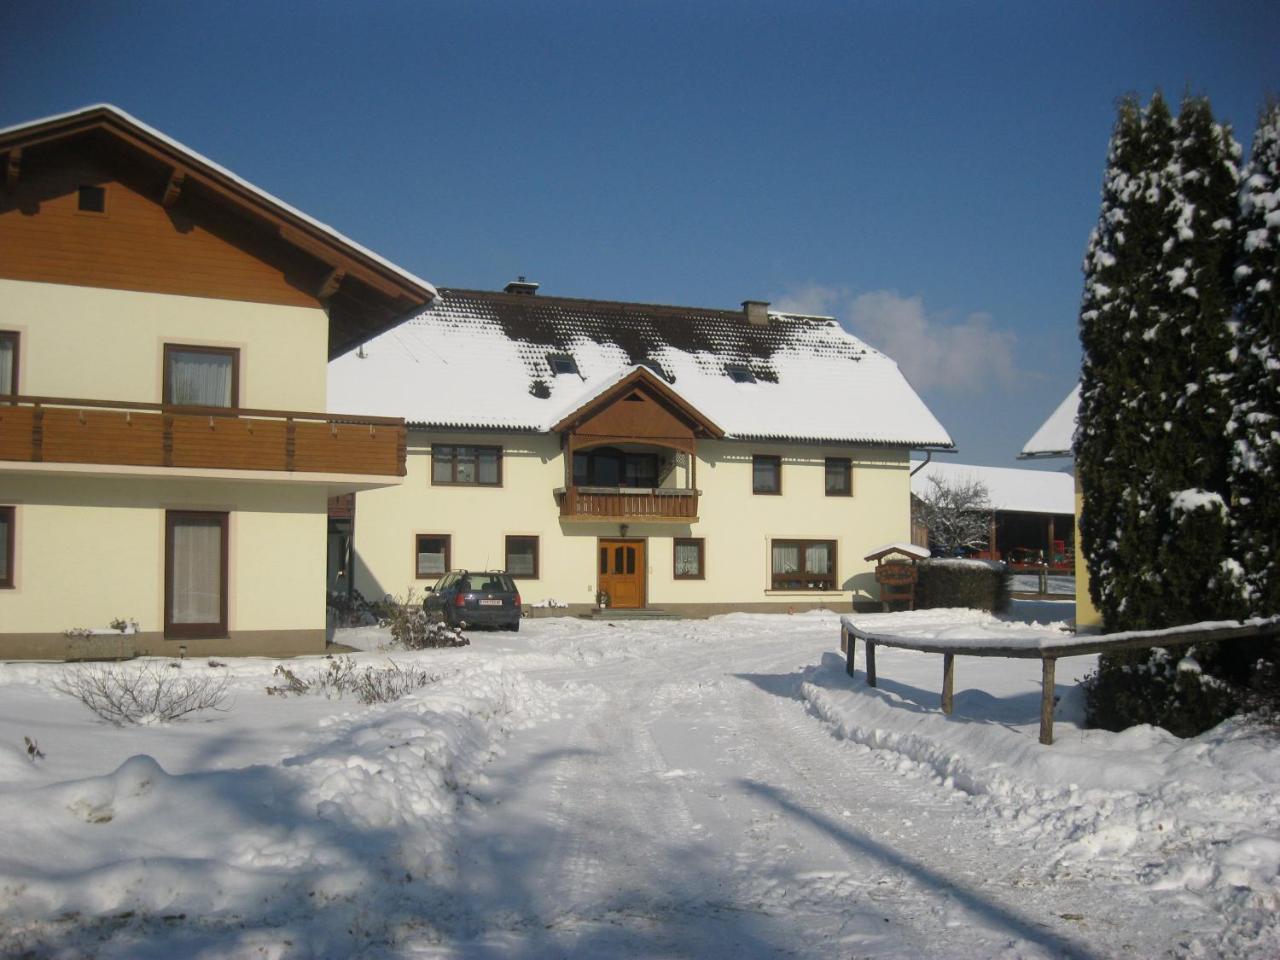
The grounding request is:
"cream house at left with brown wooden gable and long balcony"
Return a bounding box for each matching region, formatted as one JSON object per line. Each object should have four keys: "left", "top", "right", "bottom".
{"left": 0, "top": 105, "right": 435, "bottom": 658}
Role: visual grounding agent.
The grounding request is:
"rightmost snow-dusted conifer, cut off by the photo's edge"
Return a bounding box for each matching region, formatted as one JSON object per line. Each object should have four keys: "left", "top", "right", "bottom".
{"left": 1231, "top": 101, "right": 1280, "bottom": 614}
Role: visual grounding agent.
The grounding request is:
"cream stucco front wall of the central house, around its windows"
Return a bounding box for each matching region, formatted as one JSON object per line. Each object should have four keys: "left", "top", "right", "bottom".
{"left": 355, "top": 430, "right": 910, "bottom": 608}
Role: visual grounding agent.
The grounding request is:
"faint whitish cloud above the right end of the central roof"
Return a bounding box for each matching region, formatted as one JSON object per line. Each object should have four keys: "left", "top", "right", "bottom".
{"left": 774, "top": 284, "right": 1024, "bottom": 392}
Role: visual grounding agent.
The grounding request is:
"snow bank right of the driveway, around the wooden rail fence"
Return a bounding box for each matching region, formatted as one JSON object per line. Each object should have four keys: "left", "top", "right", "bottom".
{"left": 801, "top": 611, "right": 1280, "bottom": 955}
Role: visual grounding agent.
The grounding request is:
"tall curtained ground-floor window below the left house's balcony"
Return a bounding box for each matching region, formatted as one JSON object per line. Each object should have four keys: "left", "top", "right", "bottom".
{"left": 164, "top": 509, "right": 228, "bottom": 637}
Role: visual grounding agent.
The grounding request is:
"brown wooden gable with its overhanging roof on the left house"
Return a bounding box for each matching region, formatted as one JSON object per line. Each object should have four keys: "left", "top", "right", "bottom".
{"left": 0, "top": 106, "right": 435, "bottom": 357}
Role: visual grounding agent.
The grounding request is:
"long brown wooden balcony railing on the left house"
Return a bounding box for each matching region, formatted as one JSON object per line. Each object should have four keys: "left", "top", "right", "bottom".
{"left": 0, "top": 394, "right": 406, "bottom": 476}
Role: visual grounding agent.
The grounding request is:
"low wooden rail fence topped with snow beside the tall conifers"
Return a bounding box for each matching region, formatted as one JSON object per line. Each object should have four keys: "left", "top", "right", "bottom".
{"left": 840, "top": 617, "right": 1280, "bottom": 745}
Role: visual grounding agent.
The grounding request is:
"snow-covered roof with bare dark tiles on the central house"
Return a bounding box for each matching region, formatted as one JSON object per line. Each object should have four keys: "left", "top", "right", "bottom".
{"left": 329, "top": 289, "right": 952, "bottom": 447}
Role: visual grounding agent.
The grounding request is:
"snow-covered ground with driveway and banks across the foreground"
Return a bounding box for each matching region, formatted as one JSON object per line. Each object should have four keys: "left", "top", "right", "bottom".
{"left": 0, "top": 602, "right": 1280, "bottom": 957}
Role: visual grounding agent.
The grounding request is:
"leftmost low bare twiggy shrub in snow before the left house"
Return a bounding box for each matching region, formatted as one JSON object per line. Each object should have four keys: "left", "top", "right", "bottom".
{"left": 54, "top": 663, "right": 228, "bottom": 727}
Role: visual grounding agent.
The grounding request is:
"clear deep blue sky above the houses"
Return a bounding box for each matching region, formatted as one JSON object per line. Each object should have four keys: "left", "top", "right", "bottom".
{"left": 0, "top": 0, "right": 1280, "bottom": 468}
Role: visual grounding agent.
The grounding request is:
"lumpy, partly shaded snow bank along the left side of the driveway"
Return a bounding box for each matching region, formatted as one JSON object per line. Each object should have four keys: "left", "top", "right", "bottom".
{"left": 0, "top": 666, "right": 545, "bottom": 956}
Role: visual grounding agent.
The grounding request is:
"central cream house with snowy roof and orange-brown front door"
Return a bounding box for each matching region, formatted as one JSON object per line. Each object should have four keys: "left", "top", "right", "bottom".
{"left": 329, "top": 285, "right": 952, "bottom": 616}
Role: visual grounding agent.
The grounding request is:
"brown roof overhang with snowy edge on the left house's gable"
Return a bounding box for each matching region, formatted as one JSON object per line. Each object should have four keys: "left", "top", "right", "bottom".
{"left": 0, "top": 104, "right": 436, "bottom": 358}
